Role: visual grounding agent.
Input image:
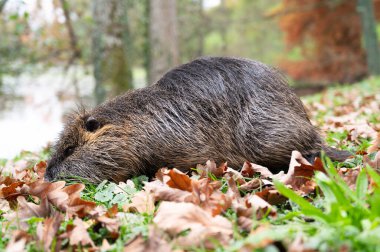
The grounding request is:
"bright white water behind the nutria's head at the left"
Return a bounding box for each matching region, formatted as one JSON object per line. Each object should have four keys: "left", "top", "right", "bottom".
{"left": 0, "top": 67, "right": 94, "bottom": 159}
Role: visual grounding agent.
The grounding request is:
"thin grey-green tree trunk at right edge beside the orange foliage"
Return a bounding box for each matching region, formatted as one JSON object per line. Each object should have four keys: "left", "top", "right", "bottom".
{"left": 357, "top": 0, "right": 380, "bottom": 75}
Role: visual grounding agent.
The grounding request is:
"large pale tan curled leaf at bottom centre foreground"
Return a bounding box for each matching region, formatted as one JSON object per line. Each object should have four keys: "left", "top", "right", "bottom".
{"left": 153, "top": 201, "right": 233, "bottom": 248}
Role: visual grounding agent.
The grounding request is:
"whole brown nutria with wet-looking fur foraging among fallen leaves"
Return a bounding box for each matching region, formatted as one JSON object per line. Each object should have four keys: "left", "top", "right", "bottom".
{"left": 45, "top": 57, "right": 347, "bottom": 182}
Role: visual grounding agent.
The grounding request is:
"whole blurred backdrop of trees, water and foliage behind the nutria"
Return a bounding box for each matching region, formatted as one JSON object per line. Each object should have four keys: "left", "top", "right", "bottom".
{"left": 0, "top": 0, "right": 380, "bottom": 158}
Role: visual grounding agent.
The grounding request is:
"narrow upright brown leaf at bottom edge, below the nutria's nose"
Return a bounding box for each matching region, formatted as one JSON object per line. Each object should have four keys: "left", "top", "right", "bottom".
{"left": 37, "top": 212, "right": 63, "bottom": 251}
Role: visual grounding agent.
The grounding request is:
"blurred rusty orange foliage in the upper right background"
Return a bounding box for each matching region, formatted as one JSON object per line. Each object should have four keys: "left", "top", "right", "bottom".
{"left": 280, "top": 0, "right": 380, "bottom": 83}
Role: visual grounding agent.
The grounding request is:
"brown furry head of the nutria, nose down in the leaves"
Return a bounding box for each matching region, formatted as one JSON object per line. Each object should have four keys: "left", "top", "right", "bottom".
{"left": 45, "top": 112, "right": 143, "bottom": 182}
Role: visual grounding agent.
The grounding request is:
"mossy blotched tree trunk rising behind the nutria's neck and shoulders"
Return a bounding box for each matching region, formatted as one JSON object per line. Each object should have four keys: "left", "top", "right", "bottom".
{"left": 92, "top": 0, "right": 133, "bottom": 103}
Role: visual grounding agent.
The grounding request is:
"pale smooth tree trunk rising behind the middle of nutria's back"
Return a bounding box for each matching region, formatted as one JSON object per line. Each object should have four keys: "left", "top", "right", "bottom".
{"left": 148, "top": 0, "right": 179, "bottom": 84}
